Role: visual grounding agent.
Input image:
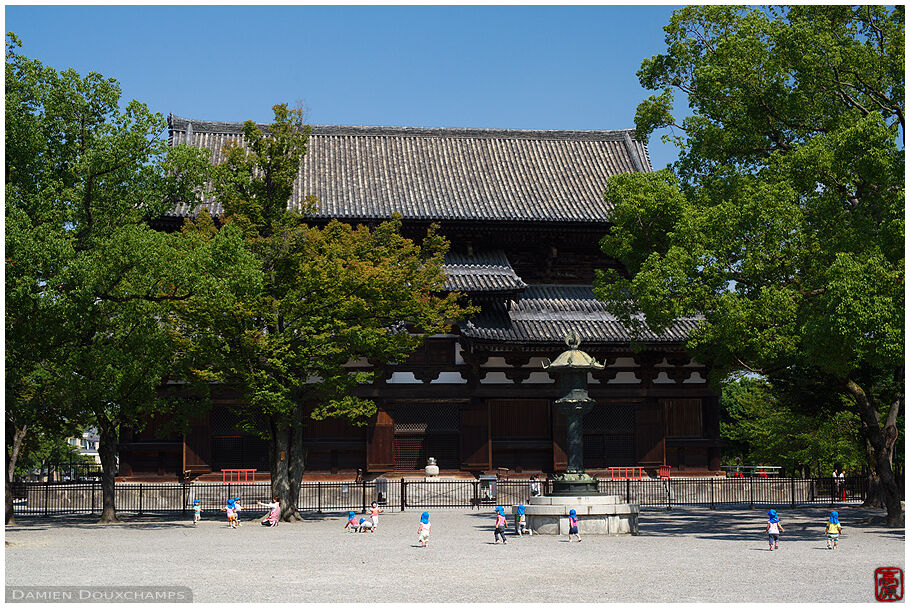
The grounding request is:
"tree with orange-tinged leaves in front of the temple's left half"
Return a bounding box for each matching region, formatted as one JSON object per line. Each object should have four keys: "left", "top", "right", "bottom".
{"left": 183, "top": 104, "right": 478, "bottom": 521}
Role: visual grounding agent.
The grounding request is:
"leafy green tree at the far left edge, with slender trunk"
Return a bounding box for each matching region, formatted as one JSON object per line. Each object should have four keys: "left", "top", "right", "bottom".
{"left": 6, "top": 34, "right": 228, "bottom": 522}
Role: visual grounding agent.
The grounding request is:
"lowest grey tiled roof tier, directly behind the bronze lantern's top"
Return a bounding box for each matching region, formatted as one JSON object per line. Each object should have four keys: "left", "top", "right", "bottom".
{"left": 459, "top": 285, "right": 699, "bottom": 344}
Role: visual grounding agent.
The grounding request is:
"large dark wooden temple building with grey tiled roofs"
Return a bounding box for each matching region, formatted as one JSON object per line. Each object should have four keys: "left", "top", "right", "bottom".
{"left": 120, "top": 116, "right": 720, "bottom": 477}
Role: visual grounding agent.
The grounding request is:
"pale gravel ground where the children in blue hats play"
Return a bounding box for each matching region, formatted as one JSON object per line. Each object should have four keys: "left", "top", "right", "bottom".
{"left": 6, "top": 507, "right": 905, "bottom": 603}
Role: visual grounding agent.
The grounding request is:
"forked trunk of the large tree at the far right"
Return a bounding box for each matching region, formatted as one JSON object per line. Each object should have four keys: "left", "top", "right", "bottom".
{"left": 845, "top": 379, "right": 904, "bottom": 527}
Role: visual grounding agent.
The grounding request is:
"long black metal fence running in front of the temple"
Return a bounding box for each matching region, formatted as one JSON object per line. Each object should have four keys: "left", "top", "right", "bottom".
{"left": 11, "top": 477, "right": 867, "bottom": 516}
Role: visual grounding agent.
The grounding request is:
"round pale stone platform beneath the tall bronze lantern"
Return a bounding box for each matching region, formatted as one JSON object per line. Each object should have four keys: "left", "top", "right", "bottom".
{"left": 512, "top": 495, "right": 639, "bottom": 534}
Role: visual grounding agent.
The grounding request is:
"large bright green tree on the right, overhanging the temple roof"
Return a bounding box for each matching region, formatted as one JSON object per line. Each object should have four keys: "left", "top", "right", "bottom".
{"left": 597, "top": 6, "right": 904, "bottom": 525}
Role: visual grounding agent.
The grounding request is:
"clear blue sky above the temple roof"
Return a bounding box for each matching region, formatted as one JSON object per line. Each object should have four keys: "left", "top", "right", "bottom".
{"left": 5, "top": 6, "right": 688, "bottom": 168}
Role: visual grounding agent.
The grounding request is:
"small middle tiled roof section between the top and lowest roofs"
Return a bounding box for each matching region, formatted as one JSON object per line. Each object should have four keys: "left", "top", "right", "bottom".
{"left": 443, "top": 250, "right": 527, "bottom": 293}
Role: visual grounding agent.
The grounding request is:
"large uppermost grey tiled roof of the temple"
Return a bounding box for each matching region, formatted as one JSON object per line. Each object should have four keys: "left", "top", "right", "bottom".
{"left": 169, "top": 115, "right": 651, "bottom": 223}
